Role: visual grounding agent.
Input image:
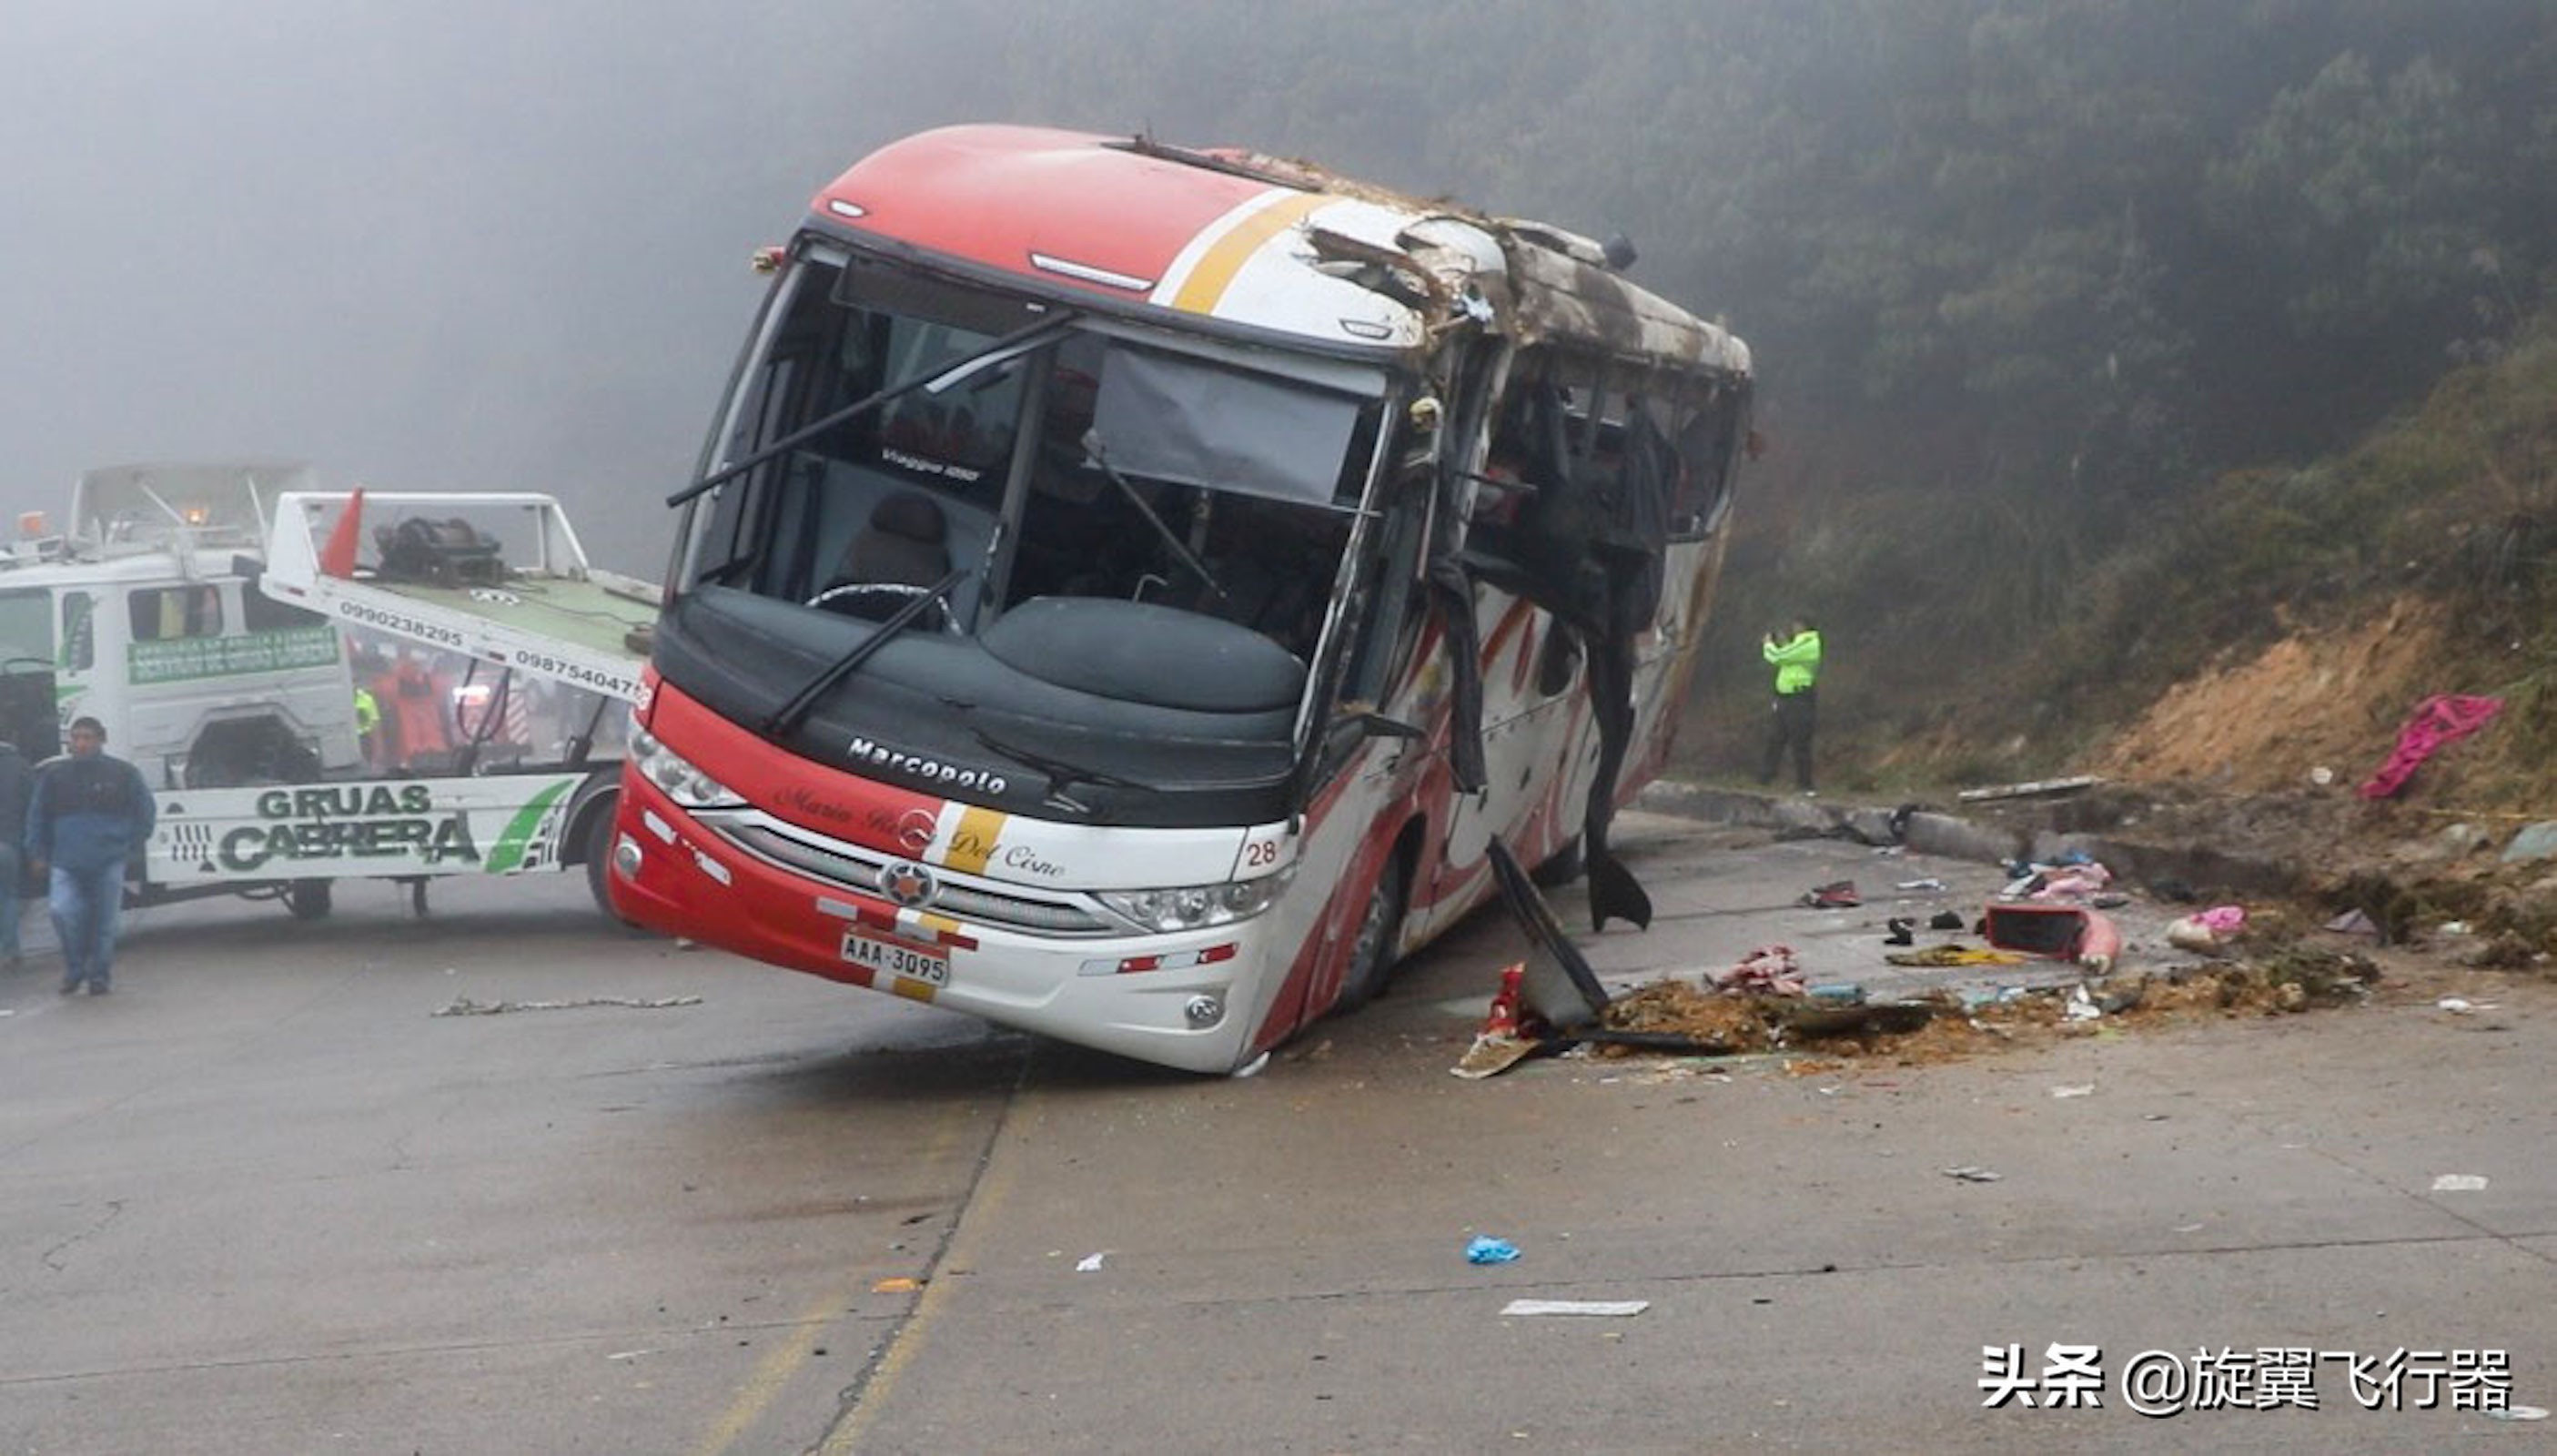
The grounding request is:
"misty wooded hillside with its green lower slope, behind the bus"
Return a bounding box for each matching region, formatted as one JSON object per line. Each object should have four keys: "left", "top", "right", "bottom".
{"left": 961, "top": 0, "right": 2557, "bottom": 798}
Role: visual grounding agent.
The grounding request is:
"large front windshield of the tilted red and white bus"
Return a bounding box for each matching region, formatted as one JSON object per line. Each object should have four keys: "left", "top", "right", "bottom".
{"left": 660, "top": 253, "right": 1409, "bottom": 822}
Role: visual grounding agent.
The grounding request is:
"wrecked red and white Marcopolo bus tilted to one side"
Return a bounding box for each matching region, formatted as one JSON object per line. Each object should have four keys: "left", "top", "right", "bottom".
{"left": 611, "top": 126, "right": 1749, "bottom": 1072}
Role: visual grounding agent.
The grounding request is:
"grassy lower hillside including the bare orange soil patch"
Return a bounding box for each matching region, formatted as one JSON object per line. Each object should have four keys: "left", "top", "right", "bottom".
{"left": 1683, "top": 318, "right": 2557, "bottom": 811}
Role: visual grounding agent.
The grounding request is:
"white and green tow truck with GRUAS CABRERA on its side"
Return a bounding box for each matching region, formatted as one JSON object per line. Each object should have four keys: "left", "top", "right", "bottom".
{"left": 0, "top": 460, "right": 657, "bottom": 918}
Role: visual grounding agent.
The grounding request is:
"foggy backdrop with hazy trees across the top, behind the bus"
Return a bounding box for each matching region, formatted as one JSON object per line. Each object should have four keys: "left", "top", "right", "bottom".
{"left": 0, "top": 0, "right": 2557, "bottom": 573}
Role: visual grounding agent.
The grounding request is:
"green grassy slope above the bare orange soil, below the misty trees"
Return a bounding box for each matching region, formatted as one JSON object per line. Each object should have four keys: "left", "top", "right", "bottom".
{"left": 1690, "top": 319, "right": 2557, "bottom": 804}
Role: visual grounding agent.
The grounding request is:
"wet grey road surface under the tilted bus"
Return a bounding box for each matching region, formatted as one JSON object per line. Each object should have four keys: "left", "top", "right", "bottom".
{"left": 0, "top": 816, "right": 2557, "bottom": 1453}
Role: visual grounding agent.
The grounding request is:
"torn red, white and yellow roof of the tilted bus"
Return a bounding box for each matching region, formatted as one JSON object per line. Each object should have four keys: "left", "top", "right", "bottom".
{"left": 811, "top": 126, "right": 1749, "bottom": 374}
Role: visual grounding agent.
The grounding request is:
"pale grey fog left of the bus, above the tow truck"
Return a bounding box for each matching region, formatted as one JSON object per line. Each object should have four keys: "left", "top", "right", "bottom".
{"left": 0, "top": 0, "right": 1048, "bottom": 576}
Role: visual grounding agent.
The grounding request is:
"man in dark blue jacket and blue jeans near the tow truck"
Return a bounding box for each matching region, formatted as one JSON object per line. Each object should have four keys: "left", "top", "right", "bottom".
{"left": 25, "top": 719, "right": 158, "bottom": 996}
